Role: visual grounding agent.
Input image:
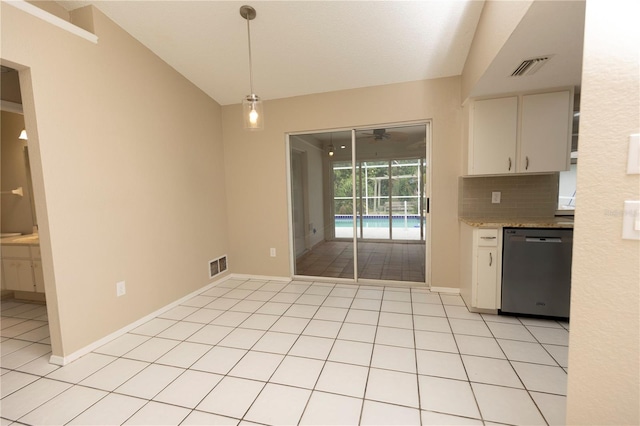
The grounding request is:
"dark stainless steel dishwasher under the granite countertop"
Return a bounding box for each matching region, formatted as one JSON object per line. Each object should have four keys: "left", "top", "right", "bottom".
{"left": 501, "top": 228, "right": 573, "bottom": 318}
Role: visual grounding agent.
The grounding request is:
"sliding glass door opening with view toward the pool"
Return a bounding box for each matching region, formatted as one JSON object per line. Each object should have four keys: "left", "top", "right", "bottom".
{"left": 288, "top": 122, "right": 431, "bottom": 285}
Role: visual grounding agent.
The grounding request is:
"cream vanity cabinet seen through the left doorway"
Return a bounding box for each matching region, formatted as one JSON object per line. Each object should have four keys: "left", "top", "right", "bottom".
{"left": 2, "top": 245, "right": 44, "bottom": 293}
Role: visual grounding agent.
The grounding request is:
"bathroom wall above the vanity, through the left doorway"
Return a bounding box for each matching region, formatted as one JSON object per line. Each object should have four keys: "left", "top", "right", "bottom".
{"left": 0, "top": 111, "right": 34, "bottom": 234}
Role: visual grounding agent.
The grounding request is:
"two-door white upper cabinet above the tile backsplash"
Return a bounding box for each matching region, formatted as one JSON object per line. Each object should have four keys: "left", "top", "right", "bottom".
{"left": 468, "top": 90, "right": 573, "bottom": 175}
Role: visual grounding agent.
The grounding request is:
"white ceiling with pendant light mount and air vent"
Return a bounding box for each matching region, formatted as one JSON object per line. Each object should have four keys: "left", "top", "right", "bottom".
{"left": 58, "top": 0, "right": 584, "bottom": 105}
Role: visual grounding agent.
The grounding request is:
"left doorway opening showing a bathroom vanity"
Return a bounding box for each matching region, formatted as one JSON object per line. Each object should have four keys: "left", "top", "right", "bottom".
{"left": 0, "top": 65, "right": 51, "bottom": 354}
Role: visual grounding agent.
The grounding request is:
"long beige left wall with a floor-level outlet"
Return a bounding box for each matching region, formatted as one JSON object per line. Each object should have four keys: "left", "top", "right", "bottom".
{"left": 0, "top": 2, "right": 233, "bottom": 356}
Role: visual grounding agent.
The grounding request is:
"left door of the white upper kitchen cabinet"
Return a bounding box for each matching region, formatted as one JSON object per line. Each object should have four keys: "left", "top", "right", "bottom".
{"left": 469, "top": 97, "right": 518, "bottom": 175}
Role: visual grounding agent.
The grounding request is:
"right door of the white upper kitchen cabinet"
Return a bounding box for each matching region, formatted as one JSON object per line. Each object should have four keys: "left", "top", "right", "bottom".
{"left": 518, "top": 90, "right": 572, "bottom": 173}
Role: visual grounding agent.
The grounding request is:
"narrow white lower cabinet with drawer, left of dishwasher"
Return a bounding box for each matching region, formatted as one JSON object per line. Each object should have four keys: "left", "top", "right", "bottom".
{"left": 460, "top": 223, "right": 502, "bottom": 311}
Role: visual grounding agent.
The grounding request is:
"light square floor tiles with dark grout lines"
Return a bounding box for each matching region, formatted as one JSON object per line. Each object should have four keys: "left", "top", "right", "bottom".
{"left": 0, "top": 279, "right": 569, "bottom": 425}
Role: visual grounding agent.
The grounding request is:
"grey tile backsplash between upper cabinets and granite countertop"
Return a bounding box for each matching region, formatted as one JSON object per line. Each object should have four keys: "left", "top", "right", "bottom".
{"left": 458, "top": 173, "right": 558, "bottom": 219}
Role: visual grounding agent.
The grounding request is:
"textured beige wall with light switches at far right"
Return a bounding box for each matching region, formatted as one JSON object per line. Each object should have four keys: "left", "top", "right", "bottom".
{"left": 567, "top": 1, "right": 640, "bottom": 425}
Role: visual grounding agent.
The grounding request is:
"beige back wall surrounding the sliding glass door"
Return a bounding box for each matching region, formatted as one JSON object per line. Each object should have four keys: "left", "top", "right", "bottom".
{"left": 222, "top": 77, "right": 462, "bottom": 288}
